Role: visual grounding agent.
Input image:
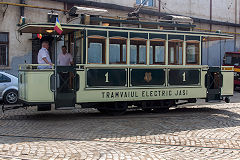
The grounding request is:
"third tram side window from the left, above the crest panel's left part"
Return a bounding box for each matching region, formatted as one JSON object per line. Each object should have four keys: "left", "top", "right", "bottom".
{"left": 130, "top": 40, "right": 147, "bottom": 64}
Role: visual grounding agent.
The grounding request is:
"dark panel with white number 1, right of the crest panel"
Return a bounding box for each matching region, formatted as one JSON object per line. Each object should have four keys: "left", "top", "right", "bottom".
{"left": 168, "top": 69, "right": 201, "bottom": 86}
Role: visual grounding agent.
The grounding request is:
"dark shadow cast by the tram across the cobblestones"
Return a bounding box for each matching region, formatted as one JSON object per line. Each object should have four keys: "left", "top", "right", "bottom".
{"left": 0, "top": 102, "right": 240, "bottom": 144}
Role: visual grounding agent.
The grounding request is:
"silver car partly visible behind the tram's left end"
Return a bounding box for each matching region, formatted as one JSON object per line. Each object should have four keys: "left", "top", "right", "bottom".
{"left": 0, "top": 72, "right": 18, "bottom": 104}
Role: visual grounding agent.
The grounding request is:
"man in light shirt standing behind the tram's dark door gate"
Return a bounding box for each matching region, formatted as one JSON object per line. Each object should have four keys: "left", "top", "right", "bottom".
{"left": 57, "top": 46, "right": 73, "bottom": 66}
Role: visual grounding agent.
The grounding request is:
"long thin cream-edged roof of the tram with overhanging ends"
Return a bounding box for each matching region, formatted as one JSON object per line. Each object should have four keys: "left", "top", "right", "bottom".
{"left": 18, "top": 23, "right": 234, "bottom": 41}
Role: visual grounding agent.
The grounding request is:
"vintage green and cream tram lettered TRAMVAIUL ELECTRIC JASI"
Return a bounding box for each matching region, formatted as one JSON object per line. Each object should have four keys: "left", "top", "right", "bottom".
{"left": 19, "top": 17, "right": 233, "bottom": 113}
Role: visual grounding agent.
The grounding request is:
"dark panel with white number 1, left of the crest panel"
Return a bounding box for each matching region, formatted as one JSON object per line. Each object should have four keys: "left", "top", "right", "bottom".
{"left": 87, "top": 69, "right": 127, "bottom": 87}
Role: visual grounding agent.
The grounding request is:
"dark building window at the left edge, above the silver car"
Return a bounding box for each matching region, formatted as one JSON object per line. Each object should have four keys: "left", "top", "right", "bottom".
{"left": 0, "top": 33, "right": 9, "bottom": 66}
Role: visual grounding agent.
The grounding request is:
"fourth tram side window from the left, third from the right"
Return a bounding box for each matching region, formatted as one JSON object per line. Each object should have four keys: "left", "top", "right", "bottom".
{"left": 150, "top": 41, "right": 165, "bottom": 64}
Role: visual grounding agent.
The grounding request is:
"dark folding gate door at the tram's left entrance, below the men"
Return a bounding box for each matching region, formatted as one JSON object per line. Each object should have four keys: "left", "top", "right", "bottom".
{"left": 55, "top": 66, "right": 76, "bottom": 109}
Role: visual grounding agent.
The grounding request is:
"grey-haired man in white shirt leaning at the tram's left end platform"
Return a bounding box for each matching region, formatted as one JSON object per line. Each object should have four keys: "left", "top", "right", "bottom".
{"left": 38, "top": 41, "right": 53, "bottom": 69}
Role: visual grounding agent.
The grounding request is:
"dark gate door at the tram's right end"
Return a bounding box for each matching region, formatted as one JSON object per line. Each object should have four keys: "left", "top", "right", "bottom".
{"left": 205, "top": 67, "right": 223, "bottom": 102}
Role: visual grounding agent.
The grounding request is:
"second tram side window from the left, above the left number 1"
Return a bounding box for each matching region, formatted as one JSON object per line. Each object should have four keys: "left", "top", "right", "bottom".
{"left": 109, "top": 39, "right": 127, "bottom": 64}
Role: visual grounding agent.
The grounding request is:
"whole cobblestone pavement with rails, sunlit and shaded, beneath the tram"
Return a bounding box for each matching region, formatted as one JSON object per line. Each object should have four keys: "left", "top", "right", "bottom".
{"left": 0, "top": 93, "right": 240, "bottom": 160}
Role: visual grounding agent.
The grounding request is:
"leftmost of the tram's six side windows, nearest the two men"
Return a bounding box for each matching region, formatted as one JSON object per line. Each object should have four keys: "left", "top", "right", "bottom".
{"left": 88, "top": 37, "right": 106, "bottom": 64}
